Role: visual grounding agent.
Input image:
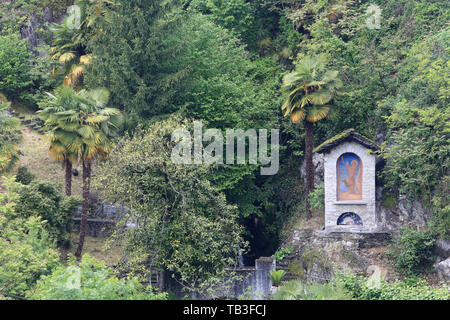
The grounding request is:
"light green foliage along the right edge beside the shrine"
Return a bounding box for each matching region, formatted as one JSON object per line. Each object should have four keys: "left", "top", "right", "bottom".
{"left": 383, "top": 27, "right": 450, "bottom": 237}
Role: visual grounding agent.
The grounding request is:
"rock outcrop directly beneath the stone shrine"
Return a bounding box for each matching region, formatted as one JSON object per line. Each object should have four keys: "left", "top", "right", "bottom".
{"left": 278, "top": 229, "right": 391, "bottom": 282}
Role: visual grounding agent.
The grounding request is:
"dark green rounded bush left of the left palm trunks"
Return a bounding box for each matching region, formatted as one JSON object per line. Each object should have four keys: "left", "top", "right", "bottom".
{"left": 15, "top": 180, "right": 81, "bottom": 244}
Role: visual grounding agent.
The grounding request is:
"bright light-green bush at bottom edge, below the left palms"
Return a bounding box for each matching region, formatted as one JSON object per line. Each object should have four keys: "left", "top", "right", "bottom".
{"left": 27, "top": 254, "right": 167, "bottom": 300}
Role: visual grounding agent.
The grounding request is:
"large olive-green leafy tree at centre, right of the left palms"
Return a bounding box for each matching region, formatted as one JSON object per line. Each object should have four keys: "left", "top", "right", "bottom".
{"left": 95, "top": 117, "right": 244, "bottom": 291}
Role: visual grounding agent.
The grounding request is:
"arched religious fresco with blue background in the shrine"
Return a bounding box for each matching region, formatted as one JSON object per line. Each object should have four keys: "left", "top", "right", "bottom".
{"left": 336, "top": 153, "right": 363, "bottom": 201}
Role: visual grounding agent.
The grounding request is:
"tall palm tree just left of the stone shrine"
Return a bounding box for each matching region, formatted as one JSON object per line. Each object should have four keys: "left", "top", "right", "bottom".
{"left": 281, "top": 55, "right": 342, "bottom": 219}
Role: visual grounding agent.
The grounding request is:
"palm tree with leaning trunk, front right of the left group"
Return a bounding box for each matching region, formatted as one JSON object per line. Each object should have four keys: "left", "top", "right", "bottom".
{"left": 41, "top": 86, "right": 123, "bottom": 258}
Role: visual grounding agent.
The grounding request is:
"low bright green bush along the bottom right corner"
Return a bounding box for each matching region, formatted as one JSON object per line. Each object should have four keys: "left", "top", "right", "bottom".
{"left": 333, "top": 274, "right": 450, "bottom": 300}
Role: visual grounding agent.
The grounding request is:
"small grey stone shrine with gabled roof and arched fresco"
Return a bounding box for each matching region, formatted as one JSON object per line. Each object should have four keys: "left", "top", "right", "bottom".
{"left": 314, "top": 129, "right": 379, "bottom": 232}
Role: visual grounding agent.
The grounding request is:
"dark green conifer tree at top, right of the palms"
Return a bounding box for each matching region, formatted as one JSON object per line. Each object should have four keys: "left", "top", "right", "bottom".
{"left": 86, "top": 0, "right": 183, "bottom": 120}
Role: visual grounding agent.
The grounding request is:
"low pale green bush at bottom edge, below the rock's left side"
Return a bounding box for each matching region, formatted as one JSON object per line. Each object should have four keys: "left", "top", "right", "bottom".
{"left": 272, "top": 280, "right": 351, "bottom": 300}
